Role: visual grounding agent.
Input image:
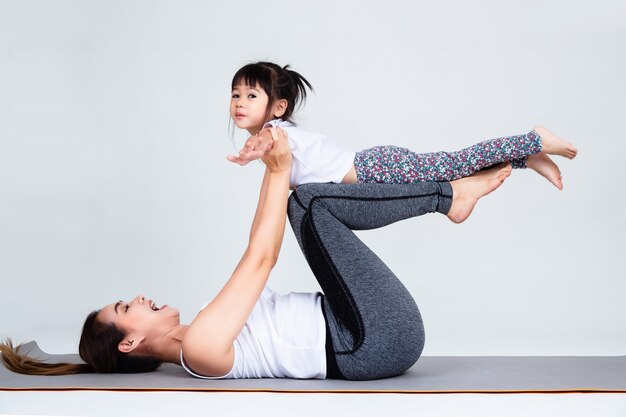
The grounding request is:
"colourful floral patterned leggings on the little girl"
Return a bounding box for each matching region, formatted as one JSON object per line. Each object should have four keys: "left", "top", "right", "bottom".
{"left": 354, "top": 130, "right": 541, "bottom": 184}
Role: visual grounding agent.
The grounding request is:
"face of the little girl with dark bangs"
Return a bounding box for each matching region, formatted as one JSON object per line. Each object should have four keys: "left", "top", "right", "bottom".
{"left": 230, "top": 84, "right": 269, "bottom": 135}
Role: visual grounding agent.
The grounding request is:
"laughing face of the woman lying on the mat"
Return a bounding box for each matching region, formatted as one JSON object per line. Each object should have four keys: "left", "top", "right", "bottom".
{"left": 98, "top": 295, "right": 180, "bottom": 346}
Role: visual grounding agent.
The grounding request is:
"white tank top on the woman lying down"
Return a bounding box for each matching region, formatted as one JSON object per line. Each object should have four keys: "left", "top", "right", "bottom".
{"left": 180, "top": 287, "right": 326, "bottom": 379}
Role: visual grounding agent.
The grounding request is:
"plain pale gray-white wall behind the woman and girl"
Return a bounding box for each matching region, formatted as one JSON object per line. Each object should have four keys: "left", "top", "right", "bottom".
{"left": 0, "top": 0, "right": 626, "bottom": 355}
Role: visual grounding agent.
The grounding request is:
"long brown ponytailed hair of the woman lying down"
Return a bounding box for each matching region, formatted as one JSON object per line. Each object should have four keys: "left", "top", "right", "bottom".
{"left": 0, "top": 311, "right": 162, "bottom": 375}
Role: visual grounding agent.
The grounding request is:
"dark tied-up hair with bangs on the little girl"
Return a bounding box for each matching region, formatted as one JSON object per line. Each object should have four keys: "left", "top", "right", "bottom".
{"left": 231, "top": 62, "right": 313, "bottom": 122}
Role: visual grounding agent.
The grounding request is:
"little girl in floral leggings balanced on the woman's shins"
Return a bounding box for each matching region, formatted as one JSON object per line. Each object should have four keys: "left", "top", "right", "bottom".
{"left": 228, "top": 62, "right": 577, "bottom": 190}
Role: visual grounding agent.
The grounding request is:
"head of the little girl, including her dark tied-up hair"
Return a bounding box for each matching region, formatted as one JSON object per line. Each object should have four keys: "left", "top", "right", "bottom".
{"left": 230, "top": 62, "right": 313, "bottom": 133}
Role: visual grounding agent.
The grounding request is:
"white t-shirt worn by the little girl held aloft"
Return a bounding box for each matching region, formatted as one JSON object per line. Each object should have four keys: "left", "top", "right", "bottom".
{"left": 263, "top": 119, "right": 355, "bottom": 187}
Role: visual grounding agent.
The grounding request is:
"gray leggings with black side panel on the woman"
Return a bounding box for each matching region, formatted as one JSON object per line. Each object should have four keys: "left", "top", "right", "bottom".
{"left": 289, "top": 182, "right": 452, "bottom": 380}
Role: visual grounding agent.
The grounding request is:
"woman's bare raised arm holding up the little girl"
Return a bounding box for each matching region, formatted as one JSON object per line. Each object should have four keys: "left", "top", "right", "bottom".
{"left": 182, "top": 130, "right": 291, "bottom": 376}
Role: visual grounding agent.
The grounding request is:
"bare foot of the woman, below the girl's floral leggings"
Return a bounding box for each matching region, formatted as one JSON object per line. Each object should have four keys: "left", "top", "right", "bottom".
{"left": 448, "top": 164, "right": 512, "bottom": 223}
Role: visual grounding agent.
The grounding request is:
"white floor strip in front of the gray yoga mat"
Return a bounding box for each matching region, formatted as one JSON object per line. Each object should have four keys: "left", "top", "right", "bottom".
{"left": 0, "top": 391, "right": 626, "bottom": 417}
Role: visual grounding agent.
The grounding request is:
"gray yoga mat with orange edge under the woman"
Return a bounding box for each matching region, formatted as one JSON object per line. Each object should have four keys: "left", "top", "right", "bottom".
{"left": 0, "top": 342, "right": 626, "bottom": 393}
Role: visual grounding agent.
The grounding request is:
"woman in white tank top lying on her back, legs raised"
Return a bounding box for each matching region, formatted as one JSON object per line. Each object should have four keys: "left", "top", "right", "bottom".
{"left": 0, "top": 128, "right": 511, "bottom": 380}
